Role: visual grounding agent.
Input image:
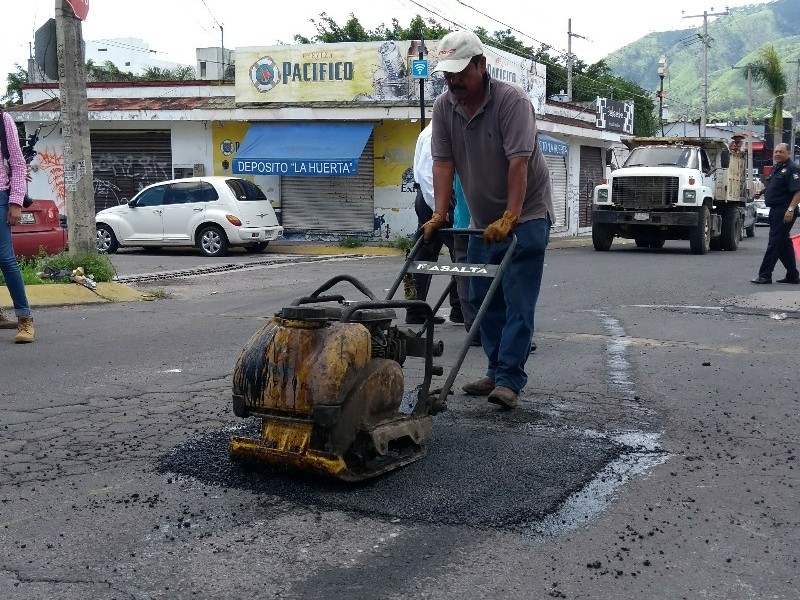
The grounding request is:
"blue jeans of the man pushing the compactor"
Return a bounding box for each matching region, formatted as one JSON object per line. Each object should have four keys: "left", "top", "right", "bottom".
{"left": 467, "top": 219, "right": 550, "bottom": 393}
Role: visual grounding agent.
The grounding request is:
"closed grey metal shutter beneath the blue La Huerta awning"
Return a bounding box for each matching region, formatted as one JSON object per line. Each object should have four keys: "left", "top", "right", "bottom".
{"left": 281, "top": 134, "right": 375, "bottom": 234}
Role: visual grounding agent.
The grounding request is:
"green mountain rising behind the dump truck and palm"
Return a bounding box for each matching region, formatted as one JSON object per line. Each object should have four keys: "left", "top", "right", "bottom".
{"left": 606, "top": 0, "right": 800, "bottom": 123}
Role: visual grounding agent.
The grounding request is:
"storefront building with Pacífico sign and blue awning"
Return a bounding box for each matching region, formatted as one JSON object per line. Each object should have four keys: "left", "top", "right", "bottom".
{"left": 11, "top": 41, "right": 619, "bottom": 240}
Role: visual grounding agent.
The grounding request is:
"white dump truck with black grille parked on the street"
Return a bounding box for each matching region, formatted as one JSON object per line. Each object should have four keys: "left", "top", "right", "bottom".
{"left": 592, "top": 137, "right": 756, "bottom": 254}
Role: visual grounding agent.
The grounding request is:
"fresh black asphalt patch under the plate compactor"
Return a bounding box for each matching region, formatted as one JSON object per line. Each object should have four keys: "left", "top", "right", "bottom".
{"left": 157, "top": 409, "right": 628, "bottom": 533}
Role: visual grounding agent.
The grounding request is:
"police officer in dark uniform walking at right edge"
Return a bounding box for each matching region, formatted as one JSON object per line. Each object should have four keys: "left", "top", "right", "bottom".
{"left": 750, "top": 144, "right": 800, "bottom": 284}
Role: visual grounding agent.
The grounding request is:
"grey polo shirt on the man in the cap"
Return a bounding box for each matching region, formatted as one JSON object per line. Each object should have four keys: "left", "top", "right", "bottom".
{"left": 431, "top": 76, "right": 553, "bottom": 229}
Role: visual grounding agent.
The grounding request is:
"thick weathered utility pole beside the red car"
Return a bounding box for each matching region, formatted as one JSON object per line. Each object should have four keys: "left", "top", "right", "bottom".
{"left": 55, "top": 0, "right": 97, "bottom": 255}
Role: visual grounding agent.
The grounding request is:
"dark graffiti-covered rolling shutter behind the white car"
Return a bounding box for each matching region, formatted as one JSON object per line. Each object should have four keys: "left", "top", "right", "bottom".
{"left": 90, "top": 131, "right": 172, "bottom": 211}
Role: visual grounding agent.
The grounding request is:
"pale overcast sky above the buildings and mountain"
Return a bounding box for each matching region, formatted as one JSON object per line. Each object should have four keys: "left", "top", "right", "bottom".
{"left": 6, "top": 0, "right": 757, "bottom": 82}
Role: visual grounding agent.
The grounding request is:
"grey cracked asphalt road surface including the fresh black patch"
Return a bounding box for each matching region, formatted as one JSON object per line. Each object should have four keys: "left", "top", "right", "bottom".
{"left": 0, "top": 228, "right": 800, "bottom": 600}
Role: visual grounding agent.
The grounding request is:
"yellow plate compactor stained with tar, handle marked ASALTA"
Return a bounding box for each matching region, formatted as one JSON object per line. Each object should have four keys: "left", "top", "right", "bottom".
{"left": 231, "top": 230, "right": 516, "bottom": 481}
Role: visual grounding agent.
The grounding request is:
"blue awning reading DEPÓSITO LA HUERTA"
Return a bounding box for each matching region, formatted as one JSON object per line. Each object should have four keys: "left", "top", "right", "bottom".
{"left": 233, "top": 122, "right": 372, "bottom": 177}
